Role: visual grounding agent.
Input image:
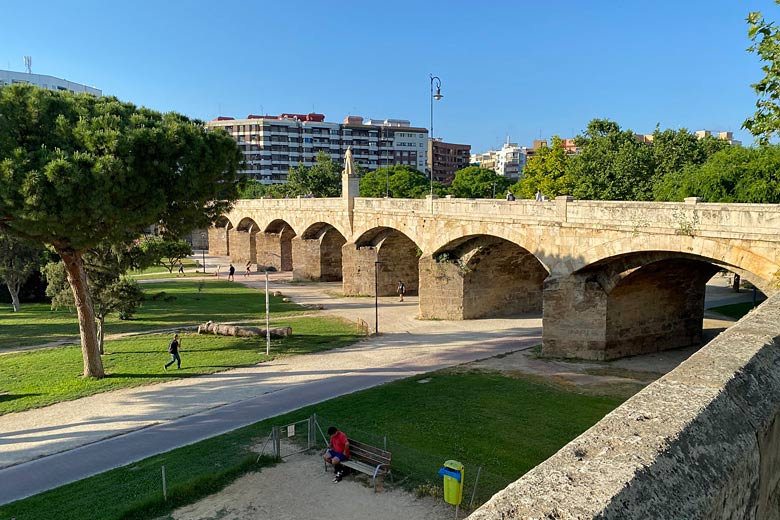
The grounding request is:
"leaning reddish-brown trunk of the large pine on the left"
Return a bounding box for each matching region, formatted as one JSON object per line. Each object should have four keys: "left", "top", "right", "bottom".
{"left": 57, "top": 248, "right": 105, "bottom": 378}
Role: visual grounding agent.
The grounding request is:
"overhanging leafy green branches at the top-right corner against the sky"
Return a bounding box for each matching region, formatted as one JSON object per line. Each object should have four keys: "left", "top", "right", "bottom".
{"left": 742, "top": 4, "right": 780, "bottom": 144}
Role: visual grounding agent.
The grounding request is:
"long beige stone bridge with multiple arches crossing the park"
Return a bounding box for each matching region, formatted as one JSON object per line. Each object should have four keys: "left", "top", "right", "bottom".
{"left": 209, "top": 189, "right": 780, "bottom": 360}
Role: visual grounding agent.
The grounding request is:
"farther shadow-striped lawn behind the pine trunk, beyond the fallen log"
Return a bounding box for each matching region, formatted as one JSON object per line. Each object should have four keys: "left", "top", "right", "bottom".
{"left": 0, "top": 280, "right": 306, "bottom": 352}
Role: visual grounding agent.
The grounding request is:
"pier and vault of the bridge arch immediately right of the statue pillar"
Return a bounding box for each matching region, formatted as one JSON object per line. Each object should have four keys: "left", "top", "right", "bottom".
{"left": 342, "top": 226, "right": 420, "bottom": 296}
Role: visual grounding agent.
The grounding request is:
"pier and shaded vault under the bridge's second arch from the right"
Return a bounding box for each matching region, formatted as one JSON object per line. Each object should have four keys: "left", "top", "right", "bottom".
{"left": 420, "top": 235, "right": 548, "bottom": 319}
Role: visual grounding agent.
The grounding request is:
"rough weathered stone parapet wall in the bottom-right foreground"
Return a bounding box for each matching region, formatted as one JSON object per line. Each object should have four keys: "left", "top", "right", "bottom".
{"left": 469, "top": 295, "right": 780, "bottom": 520}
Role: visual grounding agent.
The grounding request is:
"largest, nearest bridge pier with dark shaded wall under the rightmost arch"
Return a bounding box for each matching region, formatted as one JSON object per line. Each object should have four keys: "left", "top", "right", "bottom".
{"left": 542, "top": 259, "right": 717, "bottom": 360}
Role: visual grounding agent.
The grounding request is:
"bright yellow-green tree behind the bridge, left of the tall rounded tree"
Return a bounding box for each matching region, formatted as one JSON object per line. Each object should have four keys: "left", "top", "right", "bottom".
{"left": 510, "top": 135, "right": 572, "bottom": 199}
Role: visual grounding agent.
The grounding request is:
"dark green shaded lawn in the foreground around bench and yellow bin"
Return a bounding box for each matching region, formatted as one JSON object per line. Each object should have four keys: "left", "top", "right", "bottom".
{"left": 0, "top": 369, "right": 622, "bottom": 520}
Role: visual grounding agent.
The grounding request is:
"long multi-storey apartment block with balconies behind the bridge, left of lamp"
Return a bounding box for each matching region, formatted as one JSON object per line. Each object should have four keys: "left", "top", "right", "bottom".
{"left": 206, "top": 113, "right": 428, "bottom": 184}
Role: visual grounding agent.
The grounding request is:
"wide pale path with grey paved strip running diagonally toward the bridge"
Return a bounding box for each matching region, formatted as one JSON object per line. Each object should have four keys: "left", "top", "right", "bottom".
{"left": 0, "top": 273, "right": 541, "bottom": 504}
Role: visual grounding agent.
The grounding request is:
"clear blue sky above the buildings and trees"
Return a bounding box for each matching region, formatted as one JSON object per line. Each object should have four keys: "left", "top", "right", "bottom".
{"left": 0, "top": 0, "right": 768, "bottom": 151}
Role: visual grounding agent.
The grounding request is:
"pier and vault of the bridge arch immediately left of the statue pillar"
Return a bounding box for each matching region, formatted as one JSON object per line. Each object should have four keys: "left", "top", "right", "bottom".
{"left": 292, "top": 222, "right": 347, "bottom": 282}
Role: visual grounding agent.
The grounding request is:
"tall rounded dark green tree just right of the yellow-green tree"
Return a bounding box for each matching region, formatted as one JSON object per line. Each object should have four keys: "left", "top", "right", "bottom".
{"left": 568, "top": 119, "right": 655, "bottom": 200}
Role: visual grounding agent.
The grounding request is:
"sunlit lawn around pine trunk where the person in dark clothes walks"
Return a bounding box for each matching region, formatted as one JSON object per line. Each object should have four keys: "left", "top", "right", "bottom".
{"left": 0, "top": 317, "right": 360, "bottom": 415}
